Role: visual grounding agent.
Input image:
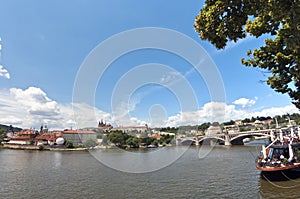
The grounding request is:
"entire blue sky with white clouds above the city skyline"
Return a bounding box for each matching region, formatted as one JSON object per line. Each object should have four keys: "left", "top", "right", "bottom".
{"left": 0, "top": 0, "right": 299, "bottom": 129}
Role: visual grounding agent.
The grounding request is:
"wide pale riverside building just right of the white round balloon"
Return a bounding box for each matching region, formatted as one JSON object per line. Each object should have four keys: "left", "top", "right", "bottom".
{"left": 62, "top": 130, "right": 97, "bottom": 146}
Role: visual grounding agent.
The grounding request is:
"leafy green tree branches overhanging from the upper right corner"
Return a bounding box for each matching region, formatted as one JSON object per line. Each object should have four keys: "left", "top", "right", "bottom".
{"left": 194, "top": 0, "right": 300, "bottom": 109}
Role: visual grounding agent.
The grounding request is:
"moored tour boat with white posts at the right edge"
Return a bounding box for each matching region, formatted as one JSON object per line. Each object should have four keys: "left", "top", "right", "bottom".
{"left": 256, "top": 127, "right": 300, "bottom": 173}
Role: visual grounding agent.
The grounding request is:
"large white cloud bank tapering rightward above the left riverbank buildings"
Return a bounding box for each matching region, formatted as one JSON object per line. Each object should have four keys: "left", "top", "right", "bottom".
{"left": 0, "top": 87, "right": 145, "bottom": 129}
